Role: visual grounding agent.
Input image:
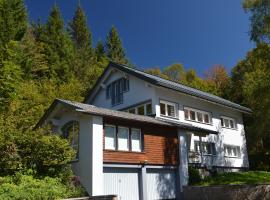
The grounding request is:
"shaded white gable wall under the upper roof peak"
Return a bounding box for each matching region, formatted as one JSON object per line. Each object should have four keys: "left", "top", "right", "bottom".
{"left": 89, "top": 71, "right": 155, "bottom": 110}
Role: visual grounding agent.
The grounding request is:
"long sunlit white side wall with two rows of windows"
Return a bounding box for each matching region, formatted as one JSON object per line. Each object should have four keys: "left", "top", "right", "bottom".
{"left": 154, "top": 88, "right": 248, "bottom": 167}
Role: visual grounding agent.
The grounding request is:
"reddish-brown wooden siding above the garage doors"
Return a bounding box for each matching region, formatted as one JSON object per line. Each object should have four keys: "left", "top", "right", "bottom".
{"left": 103, "top": 119, "right": 178, "bottom": 165}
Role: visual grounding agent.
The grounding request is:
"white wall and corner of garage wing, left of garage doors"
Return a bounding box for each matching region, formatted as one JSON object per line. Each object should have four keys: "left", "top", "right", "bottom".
{"left": 52, "top": 112, "right": 103, "bottom": 196}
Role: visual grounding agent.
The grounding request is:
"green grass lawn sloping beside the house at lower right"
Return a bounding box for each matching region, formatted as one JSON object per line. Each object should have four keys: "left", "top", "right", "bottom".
{"left": 194, "top": 171, "right": 270, "bottom": 186}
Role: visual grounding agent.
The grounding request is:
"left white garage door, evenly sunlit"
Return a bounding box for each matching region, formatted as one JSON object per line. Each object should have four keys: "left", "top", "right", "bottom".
{"left": 103, "top": 168, "right": 139, "bottom": 200}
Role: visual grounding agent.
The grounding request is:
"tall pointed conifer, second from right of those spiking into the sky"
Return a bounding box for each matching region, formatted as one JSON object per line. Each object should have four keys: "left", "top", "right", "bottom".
{"left": 68, "top": 5, "right": 92, "bottom": 49}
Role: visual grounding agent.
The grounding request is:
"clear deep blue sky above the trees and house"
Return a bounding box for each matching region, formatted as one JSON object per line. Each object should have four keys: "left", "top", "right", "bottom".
{"left": 25, "top": 0, "right": 254, "bottom": 75}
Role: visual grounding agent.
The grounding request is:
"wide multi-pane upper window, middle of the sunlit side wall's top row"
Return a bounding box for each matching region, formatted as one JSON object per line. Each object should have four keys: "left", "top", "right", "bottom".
{"left": 184, "top": 107, "right": 211, "bottom": 124}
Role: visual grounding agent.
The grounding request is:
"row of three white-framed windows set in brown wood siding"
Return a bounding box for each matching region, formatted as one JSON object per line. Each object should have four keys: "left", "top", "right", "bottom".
{"left": 104, "top": 125, "right": 142, "bottom": 152}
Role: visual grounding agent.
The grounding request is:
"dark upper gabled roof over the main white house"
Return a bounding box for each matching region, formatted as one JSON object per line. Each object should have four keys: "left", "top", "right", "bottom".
{"left": 85, "top": 62, "right": 252, "bottom": 113}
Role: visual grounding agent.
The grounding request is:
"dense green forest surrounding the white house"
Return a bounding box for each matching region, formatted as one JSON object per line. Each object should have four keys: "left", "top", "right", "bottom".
{"left": 0, "top": 0, "right": 270, "bottom": 199}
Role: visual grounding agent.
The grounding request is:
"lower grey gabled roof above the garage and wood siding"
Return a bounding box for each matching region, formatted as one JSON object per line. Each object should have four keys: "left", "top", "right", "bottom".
{"left": 35, "top": 99, "right": 218, "bottom": 134}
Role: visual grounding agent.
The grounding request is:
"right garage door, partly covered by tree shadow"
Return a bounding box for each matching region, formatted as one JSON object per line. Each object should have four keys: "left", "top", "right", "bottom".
{"left": 147, "top": 169, "right": 176, "bottom": 200}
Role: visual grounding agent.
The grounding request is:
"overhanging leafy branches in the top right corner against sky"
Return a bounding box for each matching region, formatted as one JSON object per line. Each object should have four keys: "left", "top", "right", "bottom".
{"left": 243, "top": 0, "right": 270, "bottom": 44}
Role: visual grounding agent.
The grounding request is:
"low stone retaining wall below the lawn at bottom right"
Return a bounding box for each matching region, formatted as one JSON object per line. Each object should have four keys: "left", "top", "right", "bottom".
{"left": 183, "top": 185, "right": 270, "bottom": 200}
